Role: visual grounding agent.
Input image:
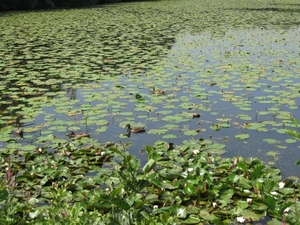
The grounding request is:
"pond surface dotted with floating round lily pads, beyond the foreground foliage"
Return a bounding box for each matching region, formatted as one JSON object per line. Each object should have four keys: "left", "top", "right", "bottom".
{"left": 0, "top": 0, "right": 300, "bottom": 179}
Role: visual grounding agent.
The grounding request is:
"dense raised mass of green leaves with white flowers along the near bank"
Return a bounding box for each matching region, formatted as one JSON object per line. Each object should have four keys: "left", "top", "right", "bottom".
{"left": 0, "top": 137, "right": 300, "bottom": 225}
